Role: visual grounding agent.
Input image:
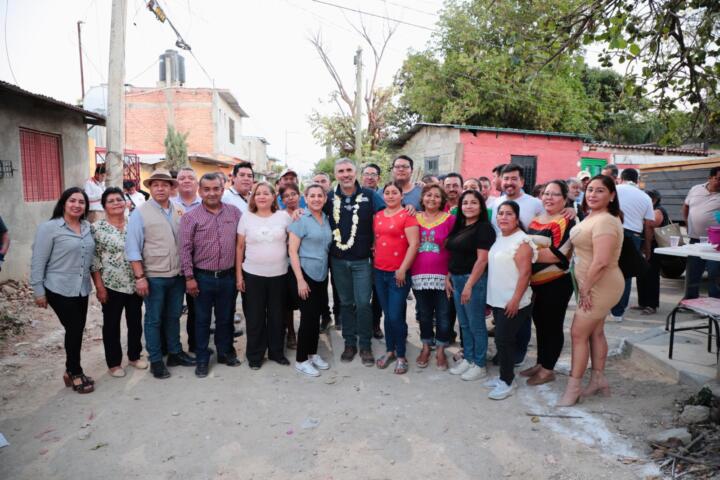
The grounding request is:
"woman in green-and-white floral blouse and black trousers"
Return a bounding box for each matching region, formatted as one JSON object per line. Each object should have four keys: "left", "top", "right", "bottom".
{"left": 90, "top": 187, "right": 148, "bottom": 377}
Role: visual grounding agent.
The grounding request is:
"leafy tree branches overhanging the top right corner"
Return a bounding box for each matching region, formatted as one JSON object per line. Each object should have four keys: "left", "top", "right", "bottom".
{"left": 542, "top": 0, "right": 720, "bottom": 136}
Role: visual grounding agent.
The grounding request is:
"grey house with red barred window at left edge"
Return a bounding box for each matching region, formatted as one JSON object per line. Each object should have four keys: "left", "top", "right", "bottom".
{"left": 0, "top": 81, "right": 105, "bottom": 280}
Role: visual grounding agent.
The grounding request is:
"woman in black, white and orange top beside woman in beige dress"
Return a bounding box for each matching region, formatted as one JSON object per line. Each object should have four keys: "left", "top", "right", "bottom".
{"left": 520, "top": 180, "right": 575, "bottom": 385}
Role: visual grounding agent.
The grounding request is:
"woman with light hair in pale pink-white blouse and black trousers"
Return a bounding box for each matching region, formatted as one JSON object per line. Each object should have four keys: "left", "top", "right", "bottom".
{"left": 236, "top": 182, "right": 291, "bottom": 370}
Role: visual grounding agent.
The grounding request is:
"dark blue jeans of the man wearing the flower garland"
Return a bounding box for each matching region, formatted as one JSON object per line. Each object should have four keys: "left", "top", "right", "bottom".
{"left": 330, "top": 257, "right": 372, "bottom": 350}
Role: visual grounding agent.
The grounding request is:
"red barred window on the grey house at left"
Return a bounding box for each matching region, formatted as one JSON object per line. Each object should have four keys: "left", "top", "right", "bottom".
{"left": 20, "top": 128, "right": 62, "bottom": 202}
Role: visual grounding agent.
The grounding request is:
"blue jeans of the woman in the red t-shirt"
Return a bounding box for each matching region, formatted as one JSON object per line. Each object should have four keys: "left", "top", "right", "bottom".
{"left": 373, "top": 268, "right": 410, "bottom": 358}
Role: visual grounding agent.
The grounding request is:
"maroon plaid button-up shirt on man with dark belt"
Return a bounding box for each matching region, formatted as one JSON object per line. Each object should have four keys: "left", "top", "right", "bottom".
{"left": 180, "top": 204, "right": 242, "bottom": 276}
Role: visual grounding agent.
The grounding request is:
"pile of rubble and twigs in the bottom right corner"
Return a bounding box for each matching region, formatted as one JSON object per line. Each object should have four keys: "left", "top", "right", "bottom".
{"left": 647, "top": 386, "right": 720, "bottom": 479}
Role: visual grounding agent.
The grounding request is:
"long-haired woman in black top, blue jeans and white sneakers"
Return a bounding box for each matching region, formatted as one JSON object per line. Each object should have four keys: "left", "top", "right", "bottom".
{"left": 446, "top": 190, "right": 495, "bottom": 381}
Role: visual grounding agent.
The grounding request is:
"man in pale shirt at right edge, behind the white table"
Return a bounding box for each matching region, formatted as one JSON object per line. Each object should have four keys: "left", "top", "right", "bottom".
{"left": 683, "top": 167, "right": 720, "bottom": 298}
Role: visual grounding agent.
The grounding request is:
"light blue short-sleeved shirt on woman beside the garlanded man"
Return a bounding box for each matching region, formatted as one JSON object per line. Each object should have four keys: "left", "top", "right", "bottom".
{"left": 288, "top": 211, "right": 332, "bottom": 282}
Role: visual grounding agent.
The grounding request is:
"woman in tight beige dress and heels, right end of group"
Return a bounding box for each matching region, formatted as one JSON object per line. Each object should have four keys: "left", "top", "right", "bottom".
{"left": 557, "top": 175, "right": 625, "bottom": 407}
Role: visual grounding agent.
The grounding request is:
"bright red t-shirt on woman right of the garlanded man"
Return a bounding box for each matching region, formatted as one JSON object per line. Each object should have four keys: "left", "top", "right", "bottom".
{"left": 373, "top": 209, "right": 418, "bottom": 272}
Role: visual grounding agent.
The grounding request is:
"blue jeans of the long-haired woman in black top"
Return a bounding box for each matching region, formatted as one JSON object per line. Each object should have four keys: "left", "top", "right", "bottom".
{"left": 450, "top": 272, "right": 487, "bottom": 367}
